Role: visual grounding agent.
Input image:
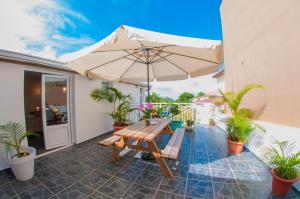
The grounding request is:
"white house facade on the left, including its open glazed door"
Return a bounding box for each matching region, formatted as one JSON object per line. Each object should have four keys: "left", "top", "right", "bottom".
{"left": 0, "top": 50, "right": 145, "bottom": 170}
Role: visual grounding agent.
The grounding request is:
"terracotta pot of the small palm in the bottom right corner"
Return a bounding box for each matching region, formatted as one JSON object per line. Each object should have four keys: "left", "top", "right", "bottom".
{"left": 271, "top": 169, "right": 298, "bottom": 196}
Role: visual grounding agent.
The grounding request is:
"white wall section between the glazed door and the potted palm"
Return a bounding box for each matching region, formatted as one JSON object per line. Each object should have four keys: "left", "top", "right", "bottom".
{"left": 74, "top": 74, "right": 113, "bottom": 143}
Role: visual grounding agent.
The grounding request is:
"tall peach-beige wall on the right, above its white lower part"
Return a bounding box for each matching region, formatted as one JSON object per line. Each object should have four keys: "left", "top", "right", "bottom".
{"left": 221, "top": 0, "right": 300, "bottom": 127}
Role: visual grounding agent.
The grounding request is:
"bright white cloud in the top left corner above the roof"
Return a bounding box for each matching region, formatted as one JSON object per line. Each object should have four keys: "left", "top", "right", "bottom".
{"left": 0, "top": 0, "right": 93, "bottom": 59}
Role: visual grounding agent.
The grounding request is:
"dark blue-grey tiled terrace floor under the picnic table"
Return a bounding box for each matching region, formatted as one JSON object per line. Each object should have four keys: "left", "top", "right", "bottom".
{"left": 0, "top": 126, "right": 300, "bottom": 199}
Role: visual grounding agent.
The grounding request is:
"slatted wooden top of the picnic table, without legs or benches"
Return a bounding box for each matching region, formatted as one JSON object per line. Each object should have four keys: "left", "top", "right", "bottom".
{"left": 114, "top": 119, "right": 170, "bottom": 141}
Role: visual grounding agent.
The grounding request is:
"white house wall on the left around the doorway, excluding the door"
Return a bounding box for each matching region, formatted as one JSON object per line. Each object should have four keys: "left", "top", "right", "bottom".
{"left": 0, "top": 61, "right": 145, "bottom": 170}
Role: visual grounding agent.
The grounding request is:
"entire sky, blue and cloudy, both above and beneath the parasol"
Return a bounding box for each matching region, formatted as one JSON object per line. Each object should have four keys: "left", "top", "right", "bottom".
{"left": 0, "top": 0, "right": 222, "bottom": 98}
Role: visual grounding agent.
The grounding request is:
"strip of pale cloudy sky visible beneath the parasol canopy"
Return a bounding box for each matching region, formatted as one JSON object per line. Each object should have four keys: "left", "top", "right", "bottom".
{"left": 151, "top": 74, "right": 224, "bottom": 99}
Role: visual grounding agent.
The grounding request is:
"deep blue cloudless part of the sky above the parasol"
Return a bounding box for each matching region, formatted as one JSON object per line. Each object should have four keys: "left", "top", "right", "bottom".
{"left": 59, "top": 0, "right": 222, "bottom": 54}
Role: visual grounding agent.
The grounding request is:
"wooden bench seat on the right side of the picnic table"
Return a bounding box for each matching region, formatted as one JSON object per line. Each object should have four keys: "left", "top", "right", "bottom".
{"left": 162, "top": 128, "right": 185, "bottom": 160}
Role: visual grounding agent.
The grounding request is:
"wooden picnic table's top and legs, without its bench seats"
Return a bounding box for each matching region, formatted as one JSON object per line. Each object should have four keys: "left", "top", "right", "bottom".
{"left": 112, "top": 119, "right": 173, "bottom": 177}
